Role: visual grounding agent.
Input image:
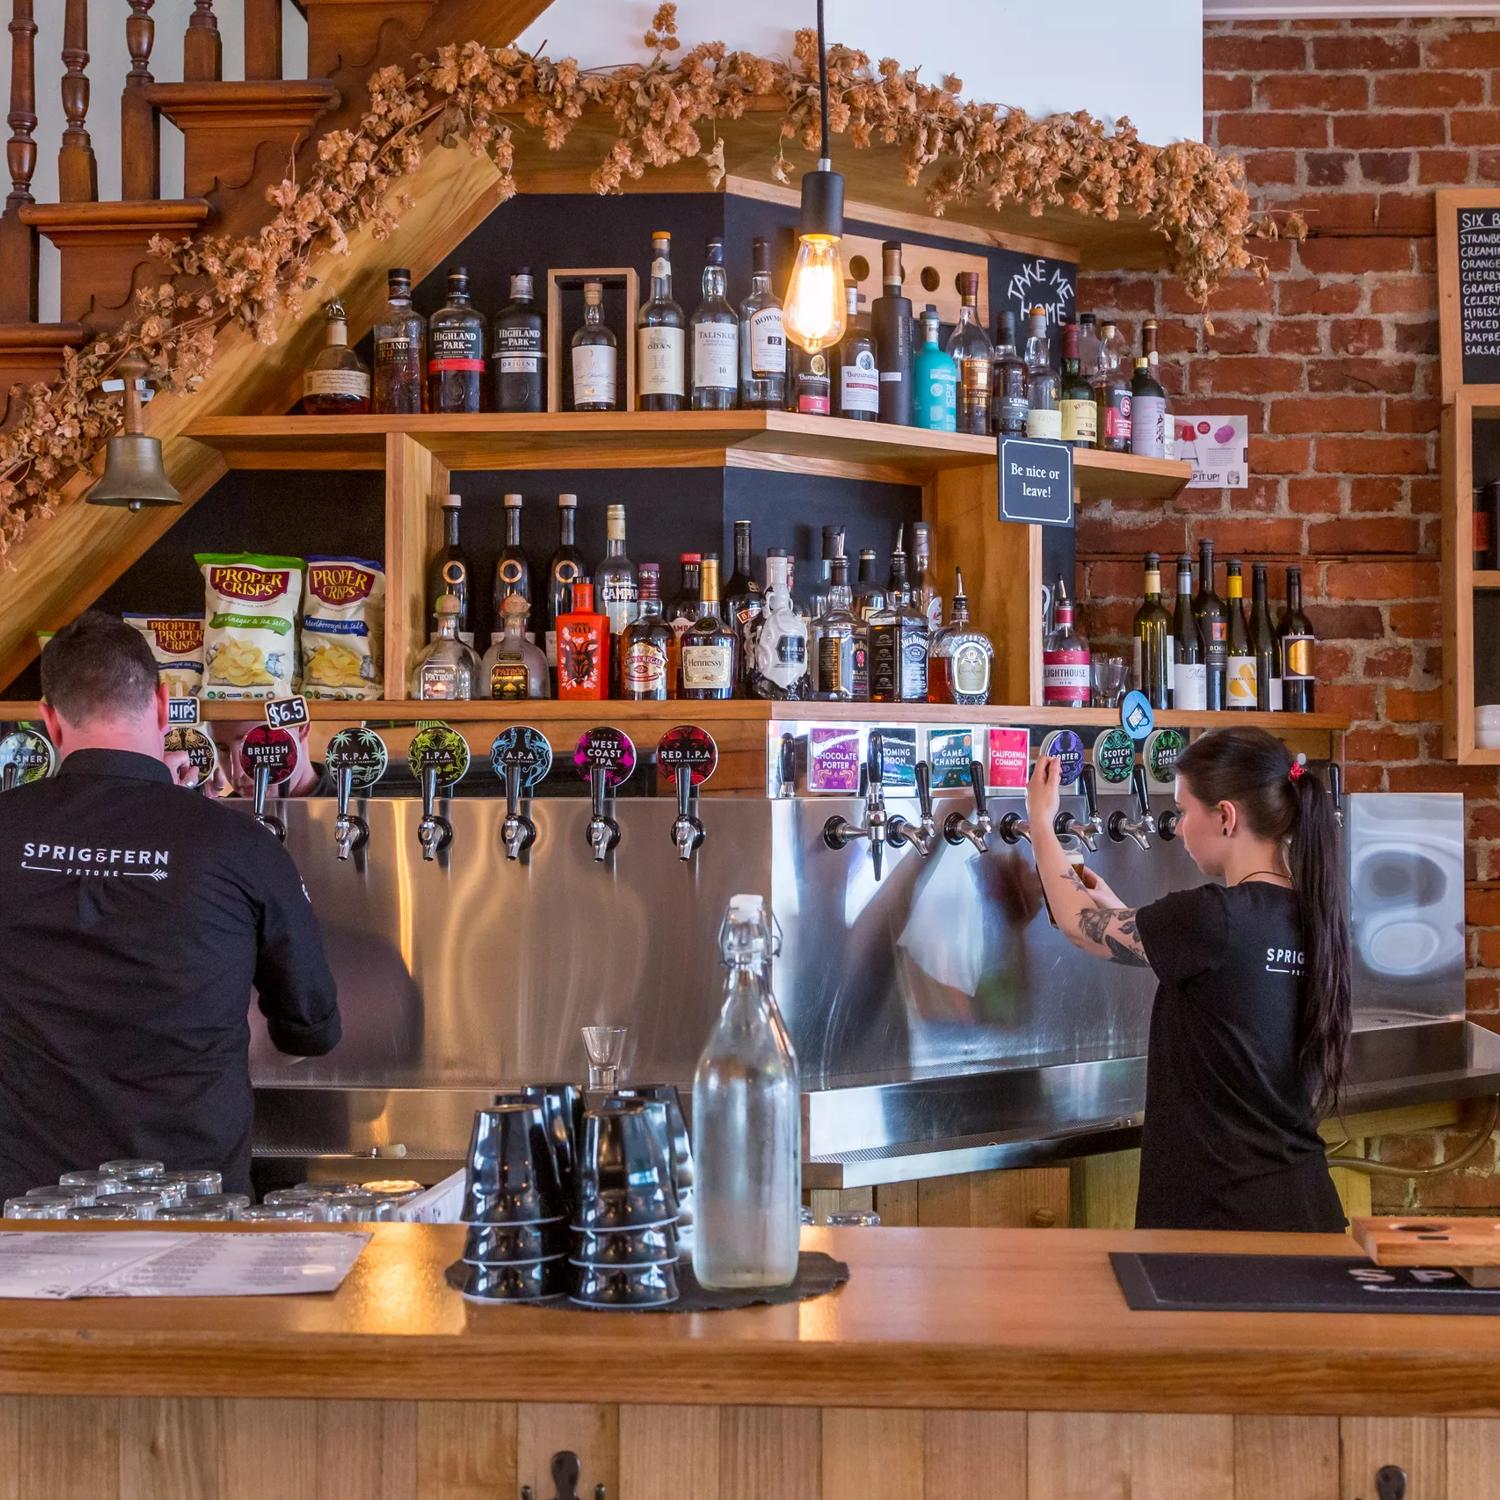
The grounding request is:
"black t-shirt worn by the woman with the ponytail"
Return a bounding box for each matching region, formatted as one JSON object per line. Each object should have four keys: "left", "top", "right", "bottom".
{"left": 1136, "top": 881, "right": 1344, "bottom": 1233}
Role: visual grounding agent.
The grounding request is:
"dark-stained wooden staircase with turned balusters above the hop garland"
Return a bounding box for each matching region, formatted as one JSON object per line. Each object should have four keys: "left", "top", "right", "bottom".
{"left": 0, "top": 0, "right": 507, "bottom": 419}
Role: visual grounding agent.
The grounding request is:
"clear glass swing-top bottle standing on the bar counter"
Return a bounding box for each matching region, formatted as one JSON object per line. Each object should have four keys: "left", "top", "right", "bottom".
{"left": 693, "top": 896, "right": 803, "bottom": 1287}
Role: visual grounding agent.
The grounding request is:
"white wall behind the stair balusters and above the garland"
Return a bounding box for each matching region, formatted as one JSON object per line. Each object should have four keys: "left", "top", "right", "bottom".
{"left": 0, "top": 0, "right": 1203, "bottom": 320}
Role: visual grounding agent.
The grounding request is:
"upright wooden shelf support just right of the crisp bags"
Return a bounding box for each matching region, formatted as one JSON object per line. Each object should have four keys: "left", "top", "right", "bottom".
{"left": 386, "top": 434, "right": 449, "bottom": 698}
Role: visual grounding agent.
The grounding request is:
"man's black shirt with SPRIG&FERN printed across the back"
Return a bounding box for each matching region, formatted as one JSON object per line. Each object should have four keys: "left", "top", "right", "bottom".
{"left": 0, "top": 750, "right": 339, "bottom": 1196}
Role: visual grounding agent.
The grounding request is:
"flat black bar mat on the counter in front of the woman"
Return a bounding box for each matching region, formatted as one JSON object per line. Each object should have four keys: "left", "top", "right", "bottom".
{"left": 1110, "top": 1253, "right": 1500, "bottom": 1314}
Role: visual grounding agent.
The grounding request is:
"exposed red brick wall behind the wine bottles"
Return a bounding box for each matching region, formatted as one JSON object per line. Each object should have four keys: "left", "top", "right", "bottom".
{"left": 1079, "top": 20, "right": 1500, "bottom": 1208}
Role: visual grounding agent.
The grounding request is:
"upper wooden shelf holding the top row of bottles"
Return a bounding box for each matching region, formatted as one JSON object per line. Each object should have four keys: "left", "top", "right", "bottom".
{"left": 189, "top": 411, "right": 1191, "bottom": 500}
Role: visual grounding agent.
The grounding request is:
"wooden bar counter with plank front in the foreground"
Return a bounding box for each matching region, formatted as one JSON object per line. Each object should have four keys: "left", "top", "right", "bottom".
{"left": 0, "top": 1226, "right": 1500, "bottom": 1500}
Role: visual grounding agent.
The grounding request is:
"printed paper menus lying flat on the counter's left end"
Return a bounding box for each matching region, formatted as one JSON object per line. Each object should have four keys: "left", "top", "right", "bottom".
{"left": 0, "top": 1230, "right": 371, "bottom": 1301}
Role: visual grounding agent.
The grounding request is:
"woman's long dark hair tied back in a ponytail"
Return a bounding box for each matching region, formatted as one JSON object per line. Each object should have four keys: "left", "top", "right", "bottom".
{"left": 1178, "top": 728, "right": 1352, "bottom": 1116}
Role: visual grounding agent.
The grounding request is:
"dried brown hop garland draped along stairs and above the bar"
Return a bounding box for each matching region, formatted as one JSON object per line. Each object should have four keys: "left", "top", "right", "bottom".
{"left": 0, "top": 5, "right": 1304, "bottom": 558}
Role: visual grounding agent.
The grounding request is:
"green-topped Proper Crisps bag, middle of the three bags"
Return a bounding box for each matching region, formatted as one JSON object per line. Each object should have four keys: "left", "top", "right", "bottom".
{"left": 197, "top": 552, "right": 303, "bottom": 699}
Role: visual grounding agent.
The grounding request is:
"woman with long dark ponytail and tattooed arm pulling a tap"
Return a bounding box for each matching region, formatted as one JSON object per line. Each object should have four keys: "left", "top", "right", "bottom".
{"left": 1026, "top": 728, "right": 1350, "bottom": 1232}
